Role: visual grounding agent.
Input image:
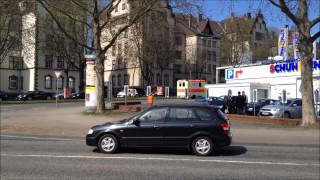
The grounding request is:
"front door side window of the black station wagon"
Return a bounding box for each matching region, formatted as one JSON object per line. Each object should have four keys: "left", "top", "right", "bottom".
{"left": 139, "top": 108, "right": 167, "bottom": 123}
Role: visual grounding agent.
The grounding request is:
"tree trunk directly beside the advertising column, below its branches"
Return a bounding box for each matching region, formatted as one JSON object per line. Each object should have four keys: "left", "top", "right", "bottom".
{"left": 95, "top": 52, "right": 105, "bottom": 113}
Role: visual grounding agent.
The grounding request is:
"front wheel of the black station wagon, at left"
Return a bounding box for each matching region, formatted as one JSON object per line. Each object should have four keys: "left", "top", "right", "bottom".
{"left": 98, "top": 134, "right": 119, "bottom": 154}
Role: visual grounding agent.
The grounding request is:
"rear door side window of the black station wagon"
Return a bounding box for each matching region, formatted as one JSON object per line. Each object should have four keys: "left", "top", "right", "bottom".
{"left": 169, "top": 108, "right": 197, "bottom": 122}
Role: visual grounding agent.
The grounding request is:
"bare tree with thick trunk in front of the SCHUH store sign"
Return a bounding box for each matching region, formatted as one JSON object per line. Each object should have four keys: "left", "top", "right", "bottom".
{"left": 269, "top": 0, "right": 320, "bottom": 126}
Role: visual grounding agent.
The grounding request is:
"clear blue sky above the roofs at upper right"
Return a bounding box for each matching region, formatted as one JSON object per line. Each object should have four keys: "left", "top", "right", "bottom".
{"left": 203, "top": 0, "right": 320, "bottom": 36}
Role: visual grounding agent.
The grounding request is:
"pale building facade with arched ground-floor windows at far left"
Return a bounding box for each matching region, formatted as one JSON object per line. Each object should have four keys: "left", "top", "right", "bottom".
{"left": 0, "top": 1, "right": 83, "bottom": 93}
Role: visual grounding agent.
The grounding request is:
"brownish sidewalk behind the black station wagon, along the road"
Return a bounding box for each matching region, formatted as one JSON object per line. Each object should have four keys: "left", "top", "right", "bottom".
{"left": 1, "top": 107, "right": 320, "bottom": 145}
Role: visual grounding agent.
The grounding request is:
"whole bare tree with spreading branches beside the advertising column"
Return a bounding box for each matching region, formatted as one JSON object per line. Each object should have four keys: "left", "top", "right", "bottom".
{"left": 37, "top": 0, "right": 157, "bottom": 113}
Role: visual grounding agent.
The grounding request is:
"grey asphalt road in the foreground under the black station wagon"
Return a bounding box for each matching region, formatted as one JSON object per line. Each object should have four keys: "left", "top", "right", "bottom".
{"left": 0, "top": 135, "right": 320, "bottom": 180}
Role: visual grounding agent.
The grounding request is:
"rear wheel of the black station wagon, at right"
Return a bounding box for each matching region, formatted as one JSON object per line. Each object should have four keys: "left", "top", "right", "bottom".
{"left": 192, "top": 136, "right": 213, "bottom": 156}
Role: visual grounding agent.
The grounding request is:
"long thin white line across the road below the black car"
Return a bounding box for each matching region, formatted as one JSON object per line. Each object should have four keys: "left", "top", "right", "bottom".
{"left": 1, "top": 154, "right": 320, "bottom": 166}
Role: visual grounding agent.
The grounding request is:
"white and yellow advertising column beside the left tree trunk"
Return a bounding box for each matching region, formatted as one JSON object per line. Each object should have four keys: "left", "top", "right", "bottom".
{"left": 85, "top": 54, "right": 97, "bottom": 112}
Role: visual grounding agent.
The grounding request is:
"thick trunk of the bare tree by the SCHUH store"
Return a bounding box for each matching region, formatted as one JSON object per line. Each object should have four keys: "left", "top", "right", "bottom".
{"left": 300, "top": 38, "right": 316, "bottom": 126}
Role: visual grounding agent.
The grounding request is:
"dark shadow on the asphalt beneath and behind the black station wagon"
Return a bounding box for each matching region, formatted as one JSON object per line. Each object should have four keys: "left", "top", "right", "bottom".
{"left": 93, "top": 146, "right": 247, "bottom": 156}
